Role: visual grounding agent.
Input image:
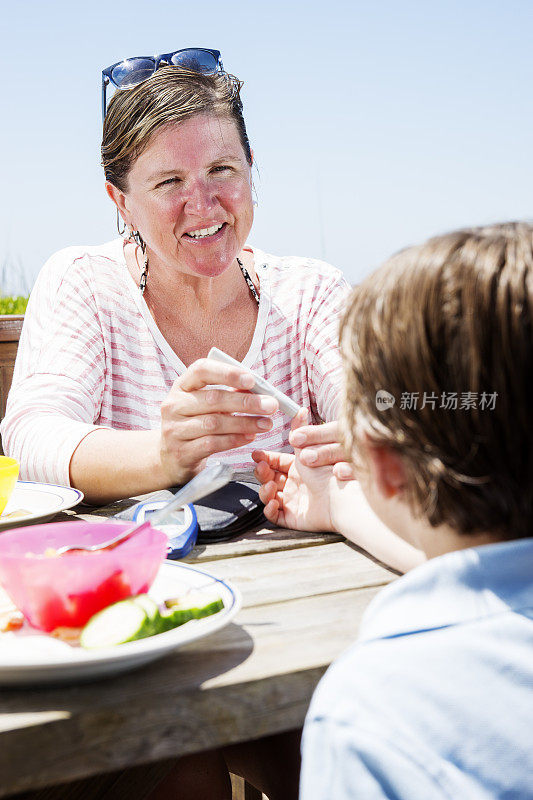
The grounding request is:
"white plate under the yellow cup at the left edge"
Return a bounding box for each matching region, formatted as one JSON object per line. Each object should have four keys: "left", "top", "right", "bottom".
{"left": 0, "top": 481, "right": 83, "bottom": 531}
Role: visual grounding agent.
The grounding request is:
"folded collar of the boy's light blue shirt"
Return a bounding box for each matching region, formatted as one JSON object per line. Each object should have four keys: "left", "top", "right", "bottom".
{"left": 359, "top": 538, "right": 533, "bottom": 641}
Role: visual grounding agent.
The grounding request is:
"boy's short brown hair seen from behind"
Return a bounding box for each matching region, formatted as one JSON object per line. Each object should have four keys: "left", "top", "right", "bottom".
{"left": 340, "top": 222, "right": 533, "bottom": 539}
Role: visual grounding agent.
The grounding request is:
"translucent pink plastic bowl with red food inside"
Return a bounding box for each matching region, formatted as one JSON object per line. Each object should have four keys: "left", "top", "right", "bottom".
{"left": 0, "top": 521, "right": 168, "bottom": 631}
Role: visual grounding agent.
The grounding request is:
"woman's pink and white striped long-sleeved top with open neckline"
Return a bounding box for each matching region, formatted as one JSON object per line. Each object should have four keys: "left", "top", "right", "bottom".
{"left": 1, "top": 239, "right": 349, "bottom": 485}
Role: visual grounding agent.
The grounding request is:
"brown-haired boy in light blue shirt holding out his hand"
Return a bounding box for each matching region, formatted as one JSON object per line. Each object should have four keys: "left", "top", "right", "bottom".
{"left": 255, "top": 223, "right": 533, "bottom": 800}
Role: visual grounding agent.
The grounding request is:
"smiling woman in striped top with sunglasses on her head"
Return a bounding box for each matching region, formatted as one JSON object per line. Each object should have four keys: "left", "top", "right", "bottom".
{"left": 2, "top": 56, "right": 348, "bottom": 504}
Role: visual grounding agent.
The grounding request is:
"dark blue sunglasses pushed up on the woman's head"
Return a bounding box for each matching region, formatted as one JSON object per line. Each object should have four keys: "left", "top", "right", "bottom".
{"left": 102, "top": 47, "right": 224, "bottom": 120}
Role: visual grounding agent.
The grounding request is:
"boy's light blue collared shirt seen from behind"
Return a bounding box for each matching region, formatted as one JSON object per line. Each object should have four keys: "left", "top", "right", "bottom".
{"left": 300, "top": 539, "right": 533, "bottom": 800}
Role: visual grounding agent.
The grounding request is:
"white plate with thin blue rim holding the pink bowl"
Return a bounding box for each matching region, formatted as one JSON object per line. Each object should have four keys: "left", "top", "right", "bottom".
{"left": 0, "top": 561, "right": 241, "bottom": 686}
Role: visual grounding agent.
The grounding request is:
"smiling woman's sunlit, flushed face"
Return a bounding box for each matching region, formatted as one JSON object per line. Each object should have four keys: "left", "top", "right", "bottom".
{"left": 115, "top": 114, "right": 253, "bottom": 277}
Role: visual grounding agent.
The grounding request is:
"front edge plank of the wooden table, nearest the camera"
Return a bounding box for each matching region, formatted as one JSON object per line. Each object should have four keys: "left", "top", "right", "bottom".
{"left": 0, "top": 587, "right": 378, "bottom": 797}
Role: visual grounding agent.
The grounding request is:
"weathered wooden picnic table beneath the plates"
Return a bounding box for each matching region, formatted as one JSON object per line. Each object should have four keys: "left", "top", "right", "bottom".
{"left": 0, "top": 490, "right": 395, "bottom": 798}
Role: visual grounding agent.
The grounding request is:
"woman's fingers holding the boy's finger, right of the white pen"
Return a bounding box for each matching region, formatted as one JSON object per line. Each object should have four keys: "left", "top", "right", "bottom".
{"left": 289, "top": 421, "right": 355, "bottom": 481}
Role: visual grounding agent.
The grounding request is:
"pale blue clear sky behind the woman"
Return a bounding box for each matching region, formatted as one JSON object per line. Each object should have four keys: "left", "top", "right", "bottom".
{"left": 0, "top": 0, "right": 533, "bottom": 291}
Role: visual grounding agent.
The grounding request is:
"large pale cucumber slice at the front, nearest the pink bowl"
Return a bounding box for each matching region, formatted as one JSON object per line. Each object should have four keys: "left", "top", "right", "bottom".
{"left": 80, "top": 597, "right": 155, "bottom": 649}
